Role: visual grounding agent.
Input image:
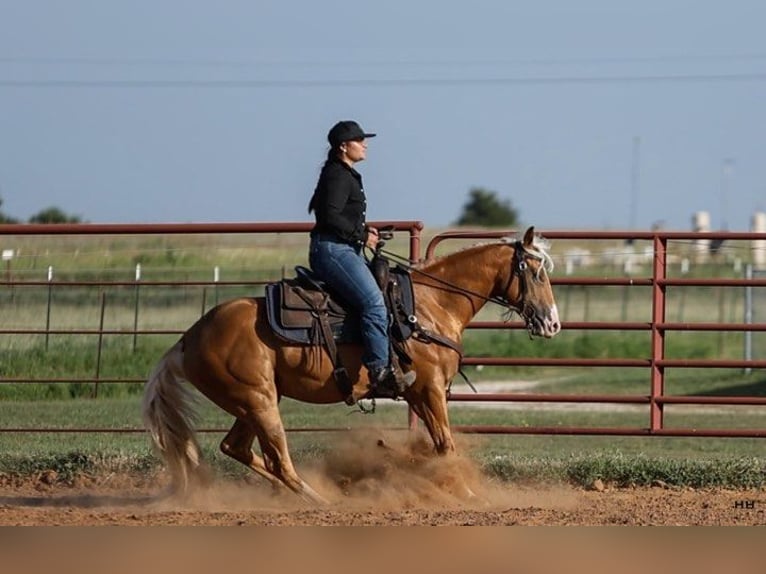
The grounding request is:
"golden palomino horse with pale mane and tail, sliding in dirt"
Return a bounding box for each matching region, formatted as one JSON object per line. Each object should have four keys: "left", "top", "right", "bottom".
{"left": 143, "top": 227, "right": 561, "bottom": 502}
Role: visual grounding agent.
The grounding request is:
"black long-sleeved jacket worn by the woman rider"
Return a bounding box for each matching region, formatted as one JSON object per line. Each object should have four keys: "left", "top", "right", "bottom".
{"left": 309, "top": 159, "right": 367, "bottom": 244}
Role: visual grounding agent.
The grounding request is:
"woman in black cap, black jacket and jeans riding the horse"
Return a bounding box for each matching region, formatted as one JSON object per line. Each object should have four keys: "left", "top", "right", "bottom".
{"left": 309, "top": 121, "right": 415, "bottom": 397}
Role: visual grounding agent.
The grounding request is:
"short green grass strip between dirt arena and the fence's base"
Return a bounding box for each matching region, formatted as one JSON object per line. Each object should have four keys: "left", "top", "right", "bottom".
{"left": 0, "top": 397, "right": 766, "bottom": 488}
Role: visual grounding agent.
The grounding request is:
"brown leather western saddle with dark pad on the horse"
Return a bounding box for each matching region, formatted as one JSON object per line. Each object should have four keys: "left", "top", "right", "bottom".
{"left": 266, "top": 254, "right": 417, "bottom": 404}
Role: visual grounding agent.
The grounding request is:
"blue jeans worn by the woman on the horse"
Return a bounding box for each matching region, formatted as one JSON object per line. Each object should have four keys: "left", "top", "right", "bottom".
{"left": 309, "top": 235, "right": 389, "bottom": 371}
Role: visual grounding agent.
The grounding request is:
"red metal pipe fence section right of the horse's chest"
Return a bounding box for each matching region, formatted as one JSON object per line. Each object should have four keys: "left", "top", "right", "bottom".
{"left": 426, "top": 231, "right": 766, "bottom": 437}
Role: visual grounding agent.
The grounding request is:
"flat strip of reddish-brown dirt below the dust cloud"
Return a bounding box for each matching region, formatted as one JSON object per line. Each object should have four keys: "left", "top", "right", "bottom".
{"left": 0, "top": 483, "right": 766, "bottom": 526}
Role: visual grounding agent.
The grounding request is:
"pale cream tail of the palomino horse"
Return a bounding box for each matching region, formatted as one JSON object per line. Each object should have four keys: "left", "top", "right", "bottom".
{"left": 141, "top": 341, "right": 204, "bottom": 493}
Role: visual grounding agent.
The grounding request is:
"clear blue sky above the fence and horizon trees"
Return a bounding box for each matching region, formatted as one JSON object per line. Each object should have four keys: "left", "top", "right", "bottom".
{"left": 0, "top": 0, "right": 766, "bottom": 230}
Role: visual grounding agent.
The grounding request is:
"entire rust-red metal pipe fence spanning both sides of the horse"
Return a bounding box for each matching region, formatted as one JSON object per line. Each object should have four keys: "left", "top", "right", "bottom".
{"left": 0, "top": 221, "right": 766, "bottom": 437}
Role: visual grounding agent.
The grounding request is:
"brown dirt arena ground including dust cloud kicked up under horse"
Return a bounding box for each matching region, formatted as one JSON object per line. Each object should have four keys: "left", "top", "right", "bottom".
{"left": 0, "top": 436, "right": 766, "bottom": 526}
